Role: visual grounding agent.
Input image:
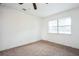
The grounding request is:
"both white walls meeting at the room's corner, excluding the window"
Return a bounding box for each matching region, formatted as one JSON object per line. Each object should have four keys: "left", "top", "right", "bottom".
{"left": 0, "top": 6, "right": 79, "bottom": 51}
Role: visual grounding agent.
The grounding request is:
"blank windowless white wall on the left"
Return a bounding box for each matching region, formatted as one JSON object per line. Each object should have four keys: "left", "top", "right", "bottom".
{"left": 0, "top": 6, "right": 40, "bottom": 50}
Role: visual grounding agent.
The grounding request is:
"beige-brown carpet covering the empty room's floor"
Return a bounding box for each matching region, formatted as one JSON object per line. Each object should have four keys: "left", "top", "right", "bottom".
{"left": 0, "top": 40, "right": 79, "bottom": 56}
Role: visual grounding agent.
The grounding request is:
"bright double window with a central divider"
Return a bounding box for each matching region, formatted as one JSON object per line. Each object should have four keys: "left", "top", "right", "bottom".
{"left": 48, "top": 17, "right": 71, "bottom": 34}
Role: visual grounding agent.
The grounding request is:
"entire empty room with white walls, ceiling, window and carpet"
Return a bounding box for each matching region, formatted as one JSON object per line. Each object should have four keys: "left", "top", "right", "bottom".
{"left": 0, "top": 3, "right": 79, "bottom": 56}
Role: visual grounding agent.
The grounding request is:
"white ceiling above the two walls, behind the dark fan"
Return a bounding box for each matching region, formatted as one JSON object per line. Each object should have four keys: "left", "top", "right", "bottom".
{"left": 2, "top": 3, "right": 79, "bottom": 17}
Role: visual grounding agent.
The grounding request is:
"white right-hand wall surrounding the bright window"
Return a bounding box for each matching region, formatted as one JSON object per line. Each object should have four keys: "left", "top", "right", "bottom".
{"left": 41, "top": 8, "right": 79, "bottom": 48}
